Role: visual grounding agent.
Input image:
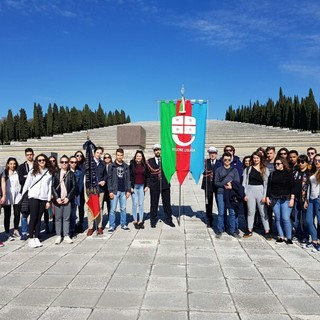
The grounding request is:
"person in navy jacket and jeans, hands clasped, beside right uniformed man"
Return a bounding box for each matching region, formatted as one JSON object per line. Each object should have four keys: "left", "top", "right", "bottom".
{"left": 214, "top": 152, "right": 240, "bottom": 239}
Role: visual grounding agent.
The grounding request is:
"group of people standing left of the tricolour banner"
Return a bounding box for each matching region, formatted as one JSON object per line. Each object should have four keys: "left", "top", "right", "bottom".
{"left": 0, "top": 144, "right": 175, "bottom": 248}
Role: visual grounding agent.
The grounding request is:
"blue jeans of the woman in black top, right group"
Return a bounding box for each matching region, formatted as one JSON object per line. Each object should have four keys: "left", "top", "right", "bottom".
{"left": 273, "top": 199, "right": 292, "bottom": 239}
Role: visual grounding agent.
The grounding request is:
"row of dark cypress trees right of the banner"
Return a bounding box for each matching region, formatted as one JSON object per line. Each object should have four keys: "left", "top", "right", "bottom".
{"left": 225, "top": 87, "right": 320, "bottom": 132}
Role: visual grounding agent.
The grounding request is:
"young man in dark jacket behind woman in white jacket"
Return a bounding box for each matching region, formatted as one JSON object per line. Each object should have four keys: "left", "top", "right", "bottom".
{"left": 18, "top": 148, "right": 34, "bottom": 241}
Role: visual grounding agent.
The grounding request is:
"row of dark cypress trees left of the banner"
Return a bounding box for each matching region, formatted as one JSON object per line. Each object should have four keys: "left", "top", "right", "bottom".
{"left": 0, "top": 103, "right": 131, "bottom": 144}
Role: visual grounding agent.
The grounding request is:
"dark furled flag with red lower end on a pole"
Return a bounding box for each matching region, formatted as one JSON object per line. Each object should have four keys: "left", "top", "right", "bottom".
{"left": 83, "top": 140, "right": 100, "bottom": 219}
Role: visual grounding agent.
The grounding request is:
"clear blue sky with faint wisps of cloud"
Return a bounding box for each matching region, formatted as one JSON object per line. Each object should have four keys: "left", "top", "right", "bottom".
{"left": 0, "top": 0, "right": 320, "bottom": 121}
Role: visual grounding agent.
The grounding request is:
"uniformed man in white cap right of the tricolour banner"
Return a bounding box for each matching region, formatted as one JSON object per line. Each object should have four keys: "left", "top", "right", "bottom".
{"left": 201, "top": 147, "right": 218, "bottom": 228}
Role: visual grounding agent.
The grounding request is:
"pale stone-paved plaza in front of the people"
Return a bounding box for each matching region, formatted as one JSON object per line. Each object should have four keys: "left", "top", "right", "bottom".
{"left": 0, "top": 178, "right": 320, "bottom": 320}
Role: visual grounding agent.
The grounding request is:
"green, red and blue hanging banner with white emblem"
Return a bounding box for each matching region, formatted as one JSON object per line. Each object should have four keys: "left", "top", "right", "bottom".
{"left": 160, "top": 99, "right": 207, "bottom": 185}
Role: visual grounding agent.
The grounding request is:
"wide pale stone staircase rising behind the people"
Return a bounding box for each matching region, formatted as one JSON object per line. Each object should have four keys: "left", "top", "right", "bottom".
{"left": 0, "top": 120, "right": 320, "bottom": 166}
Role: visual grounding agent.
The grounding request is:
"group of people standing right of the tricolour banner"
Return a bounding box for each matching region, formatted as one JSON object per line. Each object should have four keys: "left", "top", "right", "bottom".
{"left": 202, "top": 145, "right": 320, "bottom": 252}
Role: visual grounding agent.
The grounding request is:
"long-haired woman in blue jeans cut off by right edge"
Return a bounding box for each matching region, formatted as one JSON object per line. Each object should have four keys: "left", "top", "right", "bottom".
{"left": 304, "top": 153, "right": 320, "bottom": 251}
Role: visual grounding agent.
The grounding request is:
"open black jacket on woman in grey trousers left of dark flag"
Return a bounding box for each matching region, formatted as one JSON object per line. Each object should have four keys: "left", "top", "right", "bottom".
{"left": 52, "top": 169, "right": 77, "bottom": 205}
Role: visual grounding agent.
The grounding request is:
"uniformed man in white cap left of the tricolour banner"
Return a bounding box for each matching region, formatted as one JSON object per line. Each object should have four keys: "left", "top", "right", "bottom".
{"left": 147, "top": 144, "right": 175, "bottom": 228}
